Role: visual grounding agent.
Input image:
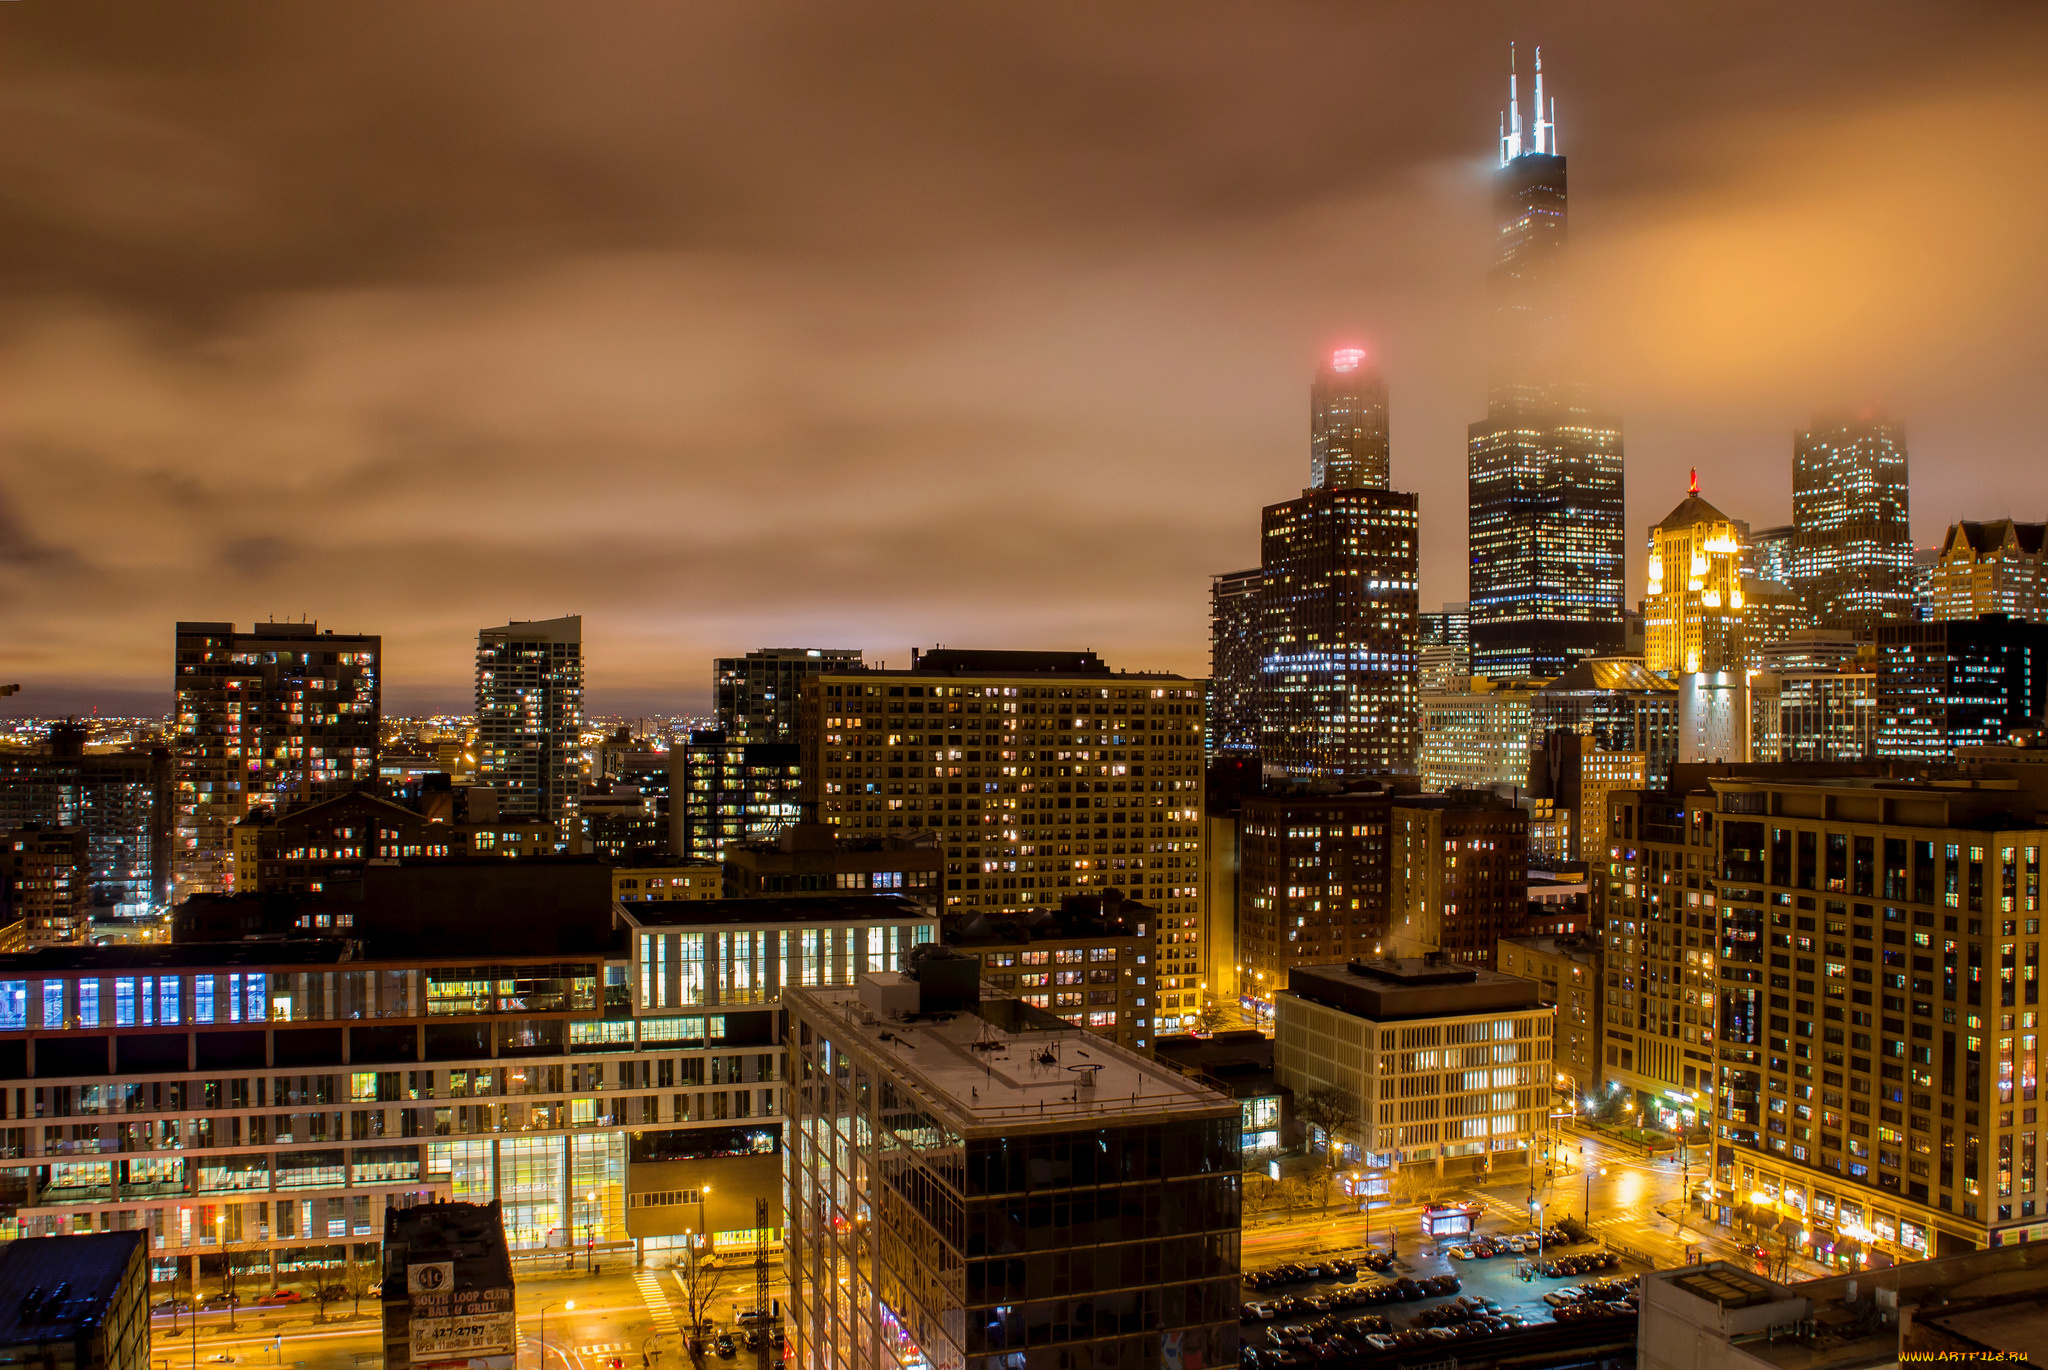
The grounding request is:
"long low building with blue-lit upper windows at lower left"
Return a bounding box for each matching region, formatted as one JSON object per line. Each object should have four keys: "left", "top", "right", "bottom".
{"left": 0, "top": 858, "right": 938, "bottom": 1282}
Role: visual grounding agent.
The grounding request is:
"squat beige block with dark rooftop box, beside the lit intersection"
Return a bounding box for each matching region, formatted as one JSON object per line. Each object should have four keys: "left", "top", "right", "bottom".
{"left": 1274, "top": 958, "right": 1556, "bottom": 1194}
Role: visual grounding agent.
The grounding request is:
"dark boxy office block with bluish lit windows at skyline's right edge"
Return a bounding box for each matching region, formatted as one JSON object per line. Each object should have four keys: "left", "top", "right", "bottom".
{"left": 1878, "top": 614, "right": 2048, "bottom": 762}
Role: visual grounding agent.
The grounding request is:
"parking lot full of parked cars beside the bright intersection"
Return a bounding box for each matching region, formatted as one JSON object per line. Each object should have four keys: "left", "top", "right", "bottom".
{"left": 1239, "top": 1239, "right": 1632, "bottom": 1370}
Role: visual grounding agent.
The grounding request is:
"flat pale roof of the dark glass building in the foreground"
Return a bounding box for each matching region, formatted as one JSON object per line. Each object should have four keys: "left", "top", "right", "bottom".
{"left": 786, "top": 971, "right": 1239, "bottom": 1134}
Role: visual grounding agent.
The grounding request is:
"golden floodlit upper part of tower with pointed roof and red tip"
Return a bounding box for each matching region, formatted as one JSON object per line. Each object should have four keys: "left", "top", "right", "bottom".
{"left": 1642, "top": 471, "right": 1747, "bottom": 676}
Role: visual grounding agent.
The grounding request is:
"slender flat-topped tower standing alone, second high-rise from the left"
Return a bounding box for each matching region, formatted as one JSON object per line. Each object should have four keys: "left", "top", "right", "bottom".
{"left": 477, "top": 616, "right": 584, "bottom": 850}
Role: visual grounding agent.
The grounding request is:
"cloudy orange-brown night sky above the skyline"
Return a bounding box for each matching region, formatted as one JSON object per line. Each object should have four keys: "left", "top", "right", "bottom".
{"left": 0, "top": 0, "right": 2048, "bottom": 715}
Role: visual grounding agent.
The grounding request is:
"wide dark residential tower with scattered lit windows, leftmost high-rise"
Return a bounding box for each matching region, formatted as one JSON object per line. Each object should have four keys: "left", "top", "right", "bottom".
{"left": 170, "top": 623, "right": 383, "bottom": 901}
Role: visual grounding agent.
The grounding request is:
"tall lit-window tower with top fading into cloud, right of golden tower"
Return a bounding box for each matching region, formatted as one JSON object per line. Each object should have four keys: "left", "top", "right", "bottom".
{"left": 1792, "top": 418, "right": 1915, "bottom": 635}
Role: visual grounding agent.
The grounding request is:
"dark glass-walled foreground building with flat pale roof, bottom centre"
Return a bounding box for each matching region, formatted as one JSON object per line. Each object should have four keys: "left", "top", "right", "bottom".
{"left": 786, "top": 991, "right": 1241, "bottom": 1370}
